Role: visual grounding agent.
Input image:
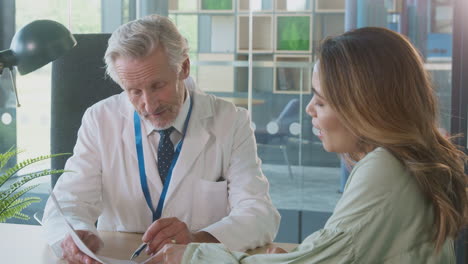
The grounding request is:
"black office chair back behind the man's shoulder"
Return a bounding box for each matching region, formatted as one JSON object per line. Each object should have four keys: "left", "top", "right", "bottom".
{"left": 50, "top": 34, "right": 122, "bottom": 187}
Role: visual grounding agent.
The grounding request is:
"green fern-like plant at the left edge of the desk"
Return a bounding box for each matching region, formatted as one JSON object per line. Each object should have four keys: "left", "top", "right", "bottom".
{"left": 0, "top": 148, "right": 68, "bottom": 222}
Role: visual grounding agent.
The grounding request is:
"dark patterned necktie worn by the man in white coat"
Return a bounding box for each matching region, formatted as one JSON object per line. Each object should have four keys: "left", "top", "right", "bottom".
{"left": 158, "top": 127, "right": 174, "bottom": 184}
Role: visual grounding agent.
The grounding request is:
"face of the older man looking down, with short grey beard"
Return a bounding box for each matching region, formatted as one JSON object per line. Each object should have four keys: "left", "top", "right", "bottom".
{"left": 115, "top": 47, "right": 190, "bottom": 130}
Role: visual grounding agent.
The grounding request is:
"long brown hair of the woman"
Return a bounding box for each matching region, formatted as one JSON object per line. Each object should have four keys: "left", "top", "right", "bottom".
{"left": 319, "top": 28, "right": 468, "bottom": 251}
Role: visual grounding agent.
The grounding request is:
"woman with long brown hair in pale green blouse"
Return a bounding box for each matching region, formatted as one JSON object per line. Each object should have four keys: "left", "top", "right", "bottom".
{"left": 148, "top": 28, "right": 467, "bottom": 263}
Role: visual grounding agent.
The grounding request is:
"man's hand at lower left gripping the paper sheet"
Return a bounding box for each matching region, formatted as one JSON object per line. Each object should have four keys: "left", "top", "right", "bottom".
{"left": 60, "top": 230, "right": 103, "bottom": 264}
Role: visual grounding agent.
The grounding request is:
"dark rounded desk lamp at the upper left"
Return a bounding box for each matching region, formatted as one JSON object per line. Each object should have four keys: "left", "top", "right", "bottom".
{"left": 0, "top": 20, "right": 76, "bottom": 106}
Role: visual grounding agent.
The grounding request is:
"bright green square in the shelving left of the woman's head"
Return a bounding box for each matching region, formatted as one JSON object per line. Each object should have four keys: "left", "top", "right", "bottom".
{"left": 276, "top": 16, "right": 310, "bottom": 51}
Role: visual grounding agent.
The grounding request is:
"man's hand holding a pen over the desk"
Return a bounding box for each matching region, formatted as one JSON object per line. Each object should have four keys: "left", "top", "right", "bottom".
{"left": 142, "top": 217, "right": 219, "bottom": 254}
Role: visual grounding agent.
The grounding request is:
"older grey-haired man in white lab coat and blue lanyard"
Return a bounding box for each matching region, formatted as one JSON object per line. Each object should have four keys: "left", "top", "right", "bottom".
{"left": 44, "top": 15, "right": 279, "bottom": 263}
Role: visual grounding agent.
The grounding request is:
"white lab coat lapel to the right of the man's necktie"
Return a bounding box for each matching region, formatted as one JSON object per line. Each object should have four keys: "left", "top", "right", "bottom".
{"left": 166, "top": 92, "right": 209, "bottom": 200}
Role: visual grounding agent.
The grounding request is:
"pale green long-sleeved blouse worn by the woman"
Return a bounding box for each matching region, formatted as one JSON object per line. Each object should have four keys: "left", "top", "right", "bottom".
{"left": 182, "top": 148, "right": 455, "bottom": 264}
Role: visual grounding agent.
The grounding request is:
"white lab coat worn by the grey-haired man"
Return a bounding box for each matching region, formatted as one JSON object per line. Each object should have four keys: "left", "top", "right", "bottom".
{"left": 43, "top": 80, "right": 280, "bottom": 252}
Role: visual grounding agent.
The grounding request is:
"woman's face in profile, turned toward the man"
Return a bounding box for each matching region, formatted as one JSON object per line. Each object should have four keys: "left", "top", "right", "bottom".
{"left": 306, "top": 70, "right": 358, "bottom": 153}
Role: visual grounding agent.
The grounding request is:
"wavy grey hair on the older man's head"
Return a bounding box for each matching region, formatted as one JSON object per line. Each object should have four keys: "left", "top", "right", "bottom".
{"left": 104, "top": 15, "right": 189, "bottom": 83}
